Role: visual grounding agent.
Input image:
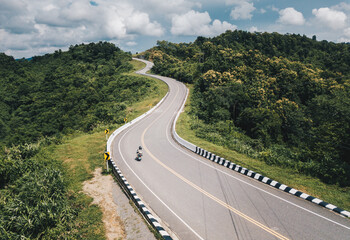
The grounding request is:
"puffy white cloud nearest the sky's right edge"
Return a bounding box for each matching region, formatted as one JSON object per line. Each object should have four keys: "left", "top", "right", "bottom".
{"left": 312, "top": 8, "right": 347, "bottom": 30}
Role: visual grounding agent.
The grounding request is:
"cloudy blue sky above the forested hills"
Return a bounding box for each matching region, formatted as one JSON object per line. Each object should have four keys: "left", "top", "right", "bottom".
{"left": 0, "top": 0, "right": 350, "bottom": 58}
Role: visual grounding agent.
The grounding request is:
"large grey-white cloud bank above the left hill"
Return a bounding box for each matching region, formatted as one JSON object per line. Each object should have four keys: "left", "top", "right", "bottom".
{"left": 36, "top": 0, "right": 164, "bottom": 38}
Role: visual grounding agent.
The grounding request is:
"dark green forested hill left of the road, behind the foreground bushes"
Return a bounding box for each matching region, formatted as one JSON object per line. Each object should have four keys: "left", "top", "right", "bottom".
{"left": 0, "top": 42, "right": 150, "bottom": 145}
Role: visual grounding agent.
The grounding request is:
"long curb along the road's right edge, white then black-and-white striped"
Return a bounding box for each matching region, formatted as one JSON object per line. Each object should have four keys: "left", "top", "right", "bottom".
{"left": 172, "top": 82, "right": 350, "bottom": 218}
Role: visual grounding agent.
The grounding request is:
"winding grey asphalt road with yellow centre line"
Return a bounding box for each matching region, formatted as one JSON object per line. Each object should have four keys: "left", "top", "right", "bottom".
{"left": 111, "top": 59, "right": 350, "bottom": 239}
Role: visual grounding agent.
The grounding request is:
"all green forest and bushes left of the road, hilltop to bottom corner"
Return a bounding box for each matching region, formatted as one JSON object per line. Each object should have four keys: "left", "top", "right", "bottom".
{"left": 0, "top": 42, "right": 159, "bottom": 239}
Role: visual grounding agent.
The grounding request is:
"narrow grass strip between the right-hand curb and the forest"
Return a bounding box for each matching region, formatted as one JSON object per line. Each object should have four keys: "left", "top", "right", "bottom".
{"left": 176, "top": 85, "right": 350, "bottom": 210}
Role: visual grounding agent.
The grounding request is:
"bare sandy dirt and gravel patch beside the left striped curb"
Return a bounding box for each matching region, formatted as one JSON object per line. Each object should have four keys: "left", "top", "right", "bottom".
{"left": 83, "top": 168, "right": 155, "bottom": 240}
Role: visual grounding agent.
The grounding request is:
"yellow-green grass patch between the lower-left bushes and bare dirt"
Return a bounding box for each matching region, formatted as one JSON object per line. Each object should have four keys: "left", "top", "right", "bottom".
{"left": 39, "top": 133, "right": 106, "bottom": 240}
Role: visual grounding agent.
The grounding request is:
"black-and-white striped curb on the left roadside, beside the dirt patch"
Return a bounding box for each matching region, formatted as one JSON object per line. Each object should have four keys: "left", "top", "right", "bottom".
{"left": 110, "top": 160, "right": 172, "bottom": 240}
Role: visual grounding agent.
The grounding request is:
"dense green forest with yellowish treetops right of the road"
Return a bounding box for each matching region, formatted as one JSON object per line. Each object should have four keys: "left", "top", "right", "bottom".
{"left": 142, "top": 31, "right": 350, "bottom": 187}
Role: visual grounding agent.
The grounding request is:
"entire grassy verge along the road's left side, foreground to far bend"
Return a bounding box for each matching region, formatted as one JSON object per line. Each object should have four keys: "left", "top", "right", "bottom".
{"left": 45, "top": 61, "right": 168, "bottom": 239}
